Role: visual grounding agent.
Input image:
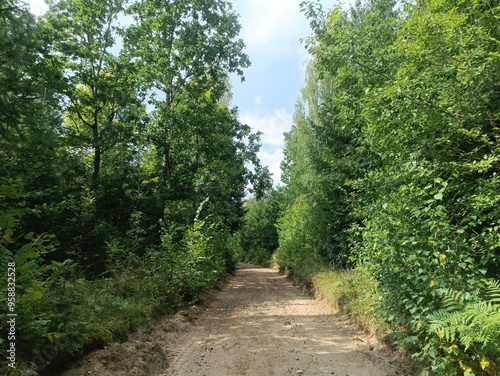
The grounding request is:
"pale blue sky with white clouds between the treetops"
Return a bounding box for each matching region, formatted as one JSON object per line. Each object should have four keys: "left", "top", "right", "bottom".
{"left": 30, "top": 0, "right": 350, "bottom": 184}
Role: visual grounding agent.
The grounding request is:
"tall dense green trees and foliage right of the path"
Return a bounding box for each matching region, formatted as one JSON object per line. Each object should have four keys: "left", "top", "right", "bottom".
{"left": 275, "top": 0, "right": 500, "bottom": 375}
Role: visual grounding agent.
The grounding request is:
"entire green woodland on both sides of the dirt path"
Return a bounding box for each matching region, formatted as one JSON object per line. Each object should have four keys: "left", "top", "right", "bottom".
{"left": 0, "top": 0, "right": 500, "bottom": 376}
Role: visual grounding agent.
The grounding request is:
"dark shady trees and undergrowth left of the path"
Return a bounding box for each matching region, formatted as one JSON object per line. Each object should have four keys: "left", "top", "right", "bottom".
{"left": 0, "top": 0, "right": 269, "bottom": 374}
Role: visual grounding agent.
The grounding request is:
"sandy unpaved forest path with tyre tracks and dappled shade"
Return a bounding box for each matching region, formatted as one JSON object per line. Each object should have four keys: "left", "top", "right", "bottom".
{"left": 62, "top": 264, "right": 397, "bottom": 376}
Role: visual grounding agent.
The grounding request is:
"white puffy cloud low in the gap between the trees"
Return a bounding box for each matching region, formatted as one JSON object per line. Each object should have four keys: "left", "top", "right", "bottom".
{"left": 240, "top": 109, "right": 293, "bottom": 146}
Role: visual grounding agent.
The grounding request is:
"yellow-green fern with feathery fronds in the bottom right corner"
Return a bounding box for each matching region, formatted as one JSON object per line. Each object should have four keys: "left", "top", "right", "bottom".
{"left": 421, "top": 280, "right": 500, "bottom": 376}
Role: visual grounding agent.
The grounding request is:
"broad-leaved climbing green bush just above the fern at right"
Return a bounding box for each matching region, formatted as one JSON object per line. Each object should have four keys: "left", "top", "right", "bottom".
{"left": 359, "top": 165, "right": 486, "bottom": 332}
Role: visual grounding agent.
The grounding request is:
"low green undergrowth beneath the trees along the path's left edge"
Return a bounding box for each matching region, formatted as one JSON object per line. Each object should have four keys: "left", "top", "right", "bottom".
{"left": 0, "top": 200, "right": 235, "bottom": 376}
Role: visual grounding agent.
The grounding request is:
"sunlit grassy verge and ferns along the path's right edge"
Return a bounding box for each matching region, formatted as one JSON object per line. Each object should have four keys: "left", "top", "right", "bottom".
{"left": 286, "top": 262, "right": 500, "bottom": 376}
